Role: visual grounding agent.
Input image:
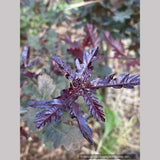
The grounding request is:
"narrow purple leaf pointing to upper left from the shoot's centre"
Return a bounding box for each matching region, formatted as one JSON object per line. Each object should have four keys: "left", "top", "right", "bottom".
{"left": 51, "top": 56, "right": 75, "bottom": 80}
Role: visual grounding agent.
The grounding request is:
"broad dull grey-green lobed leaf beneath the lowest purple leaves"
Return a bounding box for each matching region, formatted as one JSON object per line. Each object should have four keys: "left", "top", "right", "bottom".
{"left": 39, "top": 113, "right": 84, "bottom": 150}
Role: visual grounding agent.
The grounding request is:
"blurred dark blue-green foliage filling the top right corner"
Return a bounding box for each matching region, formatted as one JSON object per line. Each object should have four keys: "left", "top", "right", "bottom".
{"left": 71, "top": 0, "right": 140, "bottom": 56}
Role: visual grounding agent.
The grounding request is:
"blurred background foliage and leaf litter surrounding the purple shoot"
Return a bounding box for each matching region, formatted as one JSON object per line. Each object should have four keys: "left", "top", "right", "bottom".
{"left": 20, "top": 0, "right": 140, "bottom": 160}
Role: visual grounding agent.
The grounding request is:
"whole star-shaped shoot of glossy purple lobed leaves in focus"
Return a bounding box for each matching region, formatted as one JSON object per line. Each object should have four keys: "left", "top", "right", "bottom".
{"left": 28, "top": 47, "right": 140, "bottom": 144}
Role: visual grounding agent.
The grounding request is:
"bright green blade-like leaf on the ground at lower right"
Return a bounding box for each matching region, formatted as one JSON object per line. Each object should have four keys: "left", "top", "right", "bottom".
{"left": 96, "top": 90, "right": 121, "bottom": 154}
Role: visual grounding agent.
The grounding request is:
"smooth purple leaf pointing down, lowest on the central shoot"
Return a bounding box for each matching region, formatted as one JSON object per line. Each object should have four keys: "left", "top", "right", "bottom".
{"left": 70, "top": 103, "right": 93, "bottom": 144}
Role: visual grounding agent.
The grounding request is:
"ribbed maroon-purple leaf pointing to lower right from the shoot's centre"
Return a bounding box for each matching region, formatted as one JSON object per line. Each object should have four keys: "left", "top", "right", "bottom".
{"left": 82, "top": 90, "right": 105, "bottom": 121}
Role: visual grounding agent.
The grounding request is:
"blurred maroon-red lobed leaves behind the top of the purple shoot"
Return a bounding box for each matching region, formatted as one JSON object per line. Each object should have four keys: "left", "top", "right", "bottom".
{"left": 61, "top": 23, "right": 139, "bottom": 67}
